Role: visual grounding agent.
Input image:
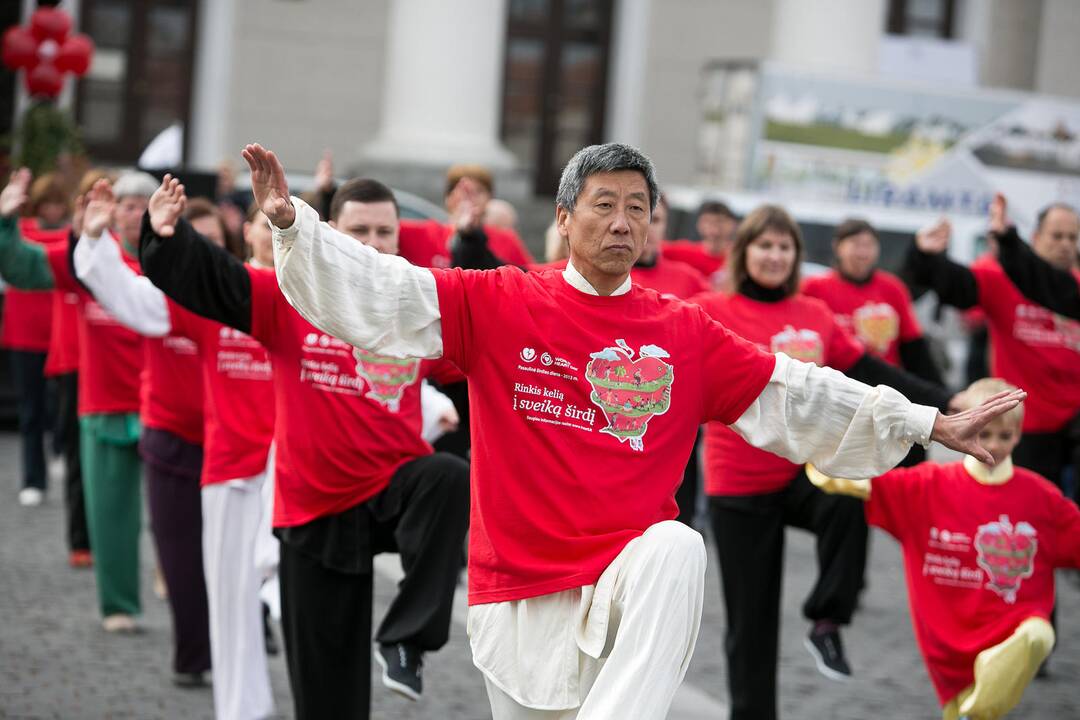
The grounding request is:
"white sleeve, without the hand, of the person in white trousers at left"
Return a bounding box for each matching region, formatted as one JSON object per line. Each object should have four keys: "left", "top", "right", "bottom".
{"left": 73, "top": 230, "right": 173, "bottom": 338}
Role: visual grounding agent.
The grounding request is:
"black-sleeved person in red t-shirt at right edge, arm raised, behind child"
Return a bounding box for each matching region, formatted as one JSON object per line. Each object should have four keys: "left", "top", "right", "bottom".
{"left": 907, "top": 203, "right": 1080, "bottom": 496}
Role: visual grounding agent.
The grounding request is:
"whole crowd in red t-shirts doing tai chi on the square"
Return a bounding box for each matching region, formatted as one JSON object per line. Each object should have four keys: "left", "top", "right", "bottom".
{"left": 0, "top": 136, "right": 1080, "bottom": 720}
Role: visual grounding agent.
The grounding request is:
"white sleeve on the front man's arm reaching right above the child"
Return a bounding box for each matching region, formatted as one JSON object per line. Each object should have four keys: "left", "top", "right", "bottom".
{"left": 731, "top": 353, "right": 937, "bottom": 477}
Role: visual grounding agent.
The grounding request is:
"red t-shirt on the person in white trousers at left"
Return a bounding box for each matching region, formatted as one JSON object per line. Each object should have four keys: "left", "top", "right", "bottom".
{"left": 168, "top": 301, "right": 274, "bottom": 486}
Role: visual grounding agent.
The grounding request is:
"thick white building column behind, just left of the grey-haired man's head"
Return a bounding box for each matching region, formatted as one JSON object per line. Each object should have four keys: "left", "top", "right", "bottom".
{"left": 363, "top": 0, "right": 514, "bottom": 168}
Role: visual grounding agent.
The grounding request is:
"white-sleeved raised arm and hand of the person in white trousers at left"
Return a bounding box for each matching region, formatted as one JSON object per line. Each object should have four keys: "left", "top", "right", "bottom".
{"left": 73, "top": 180, "right": 172, "bottom": 338}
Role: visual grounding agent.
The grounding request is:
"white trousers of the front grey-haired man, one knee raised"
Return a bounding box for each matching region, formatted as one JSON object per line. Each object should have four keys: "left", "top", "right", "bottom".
{"left": 470, "top": 521, "right": 705, "bottom": 720}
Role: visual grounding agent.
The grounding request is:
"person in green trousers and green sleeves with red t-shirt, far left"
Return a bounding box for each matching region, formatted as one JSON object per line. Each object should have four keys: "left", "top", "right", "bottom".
{"left": 0, "top": 169, "right": 157, "bottom": 631}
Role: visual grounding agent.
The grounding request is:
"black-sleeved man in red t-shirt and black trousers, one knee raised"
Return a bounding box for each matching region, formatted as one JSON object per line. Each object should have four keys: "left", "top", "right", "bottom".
{"left": 140, "top": 177, "right": 469, "bottom": 718}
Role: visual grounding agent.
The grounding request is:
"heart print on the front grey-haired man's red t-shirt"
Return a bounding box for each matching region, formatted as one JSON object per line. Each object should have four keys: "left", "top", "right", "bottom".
{"left": 585, "top": 340, "right": 675, "bottom": 451}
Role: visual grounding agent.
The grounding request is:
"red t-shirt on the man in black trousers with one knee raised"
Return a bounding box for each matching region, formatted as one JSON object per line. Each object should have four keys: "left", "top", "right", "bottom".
{"left": 247, "top": 267, "right": 442, "bottom": 527}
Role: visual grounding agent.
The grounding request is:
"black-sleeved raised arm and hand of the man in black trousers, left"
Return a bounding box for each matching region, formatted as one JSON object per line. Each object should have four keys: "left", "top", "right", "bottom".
{"left": 139, "top": 175, "right": 252, "bottom": 332}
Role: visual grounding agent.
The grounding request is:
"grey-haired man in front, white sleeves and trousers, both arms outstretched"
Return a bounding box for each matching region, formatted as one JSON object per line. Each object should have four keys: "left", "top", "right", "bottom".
{"left": 243, "top": 144, "right": 1023, "bottom": 720}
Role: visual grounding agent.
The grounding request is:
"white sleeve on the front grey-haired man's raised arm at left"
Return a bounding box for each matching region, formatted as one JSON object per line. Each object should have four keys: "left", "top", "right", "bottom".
{"left": 271, "top": 198, "right": 443, "bottom": 358}
